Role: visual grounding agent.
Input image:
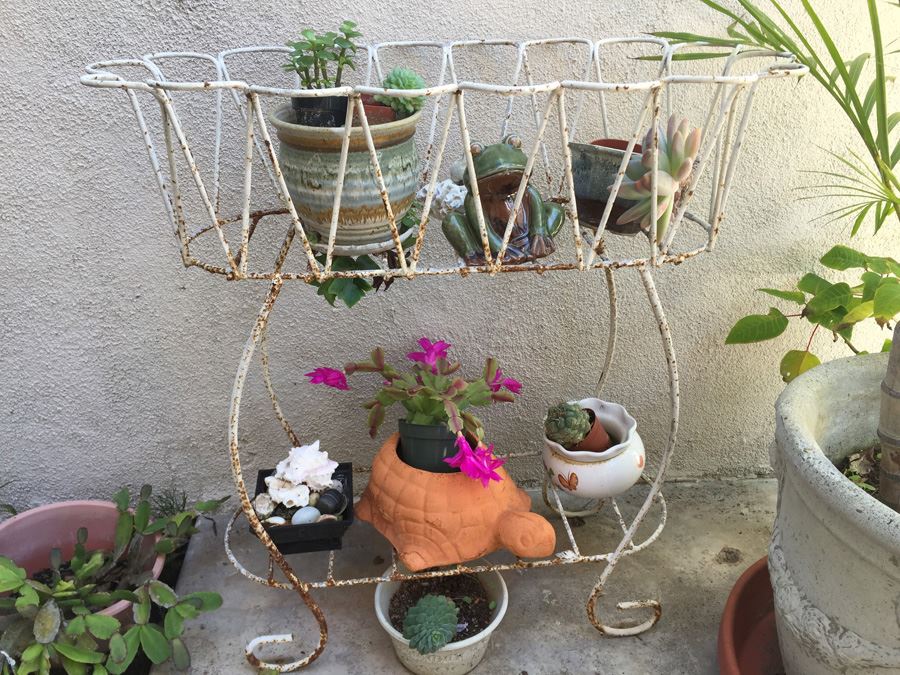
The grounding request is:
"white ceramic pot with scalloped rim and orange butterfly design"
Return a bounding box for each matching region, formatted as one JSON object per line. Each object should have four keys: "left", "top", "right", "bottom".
{"left": 544, "top": 398, "right": 644, "bottom": 499}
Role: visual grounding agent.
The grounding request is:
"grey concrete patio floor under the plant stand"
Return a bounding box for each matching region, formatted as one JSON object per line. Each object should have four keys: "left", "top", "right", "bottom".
{"left": 154, "top": 479, "right": 776, "bottom": 675}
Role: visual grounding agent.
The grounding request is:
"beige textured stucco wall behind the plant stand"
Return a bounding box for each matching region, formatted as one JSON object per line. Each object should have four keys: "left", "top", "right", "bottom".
{"left": 0, "top": 0, "right": 900, "bottom": 506}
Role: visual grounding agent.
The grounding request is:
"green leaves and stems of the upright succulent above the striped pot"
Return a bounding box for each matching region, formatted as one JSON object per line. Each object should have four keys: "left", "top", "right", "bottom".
{"left": 282, "top": 21, "right": 362, "bottom": 89}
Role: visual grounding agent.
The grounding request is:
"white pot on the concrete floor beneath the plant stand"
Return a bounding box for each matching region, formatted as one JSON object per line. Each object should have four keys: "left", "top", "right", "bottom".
{"left": 375, "top": 572, "right": 509, "bottom": 675}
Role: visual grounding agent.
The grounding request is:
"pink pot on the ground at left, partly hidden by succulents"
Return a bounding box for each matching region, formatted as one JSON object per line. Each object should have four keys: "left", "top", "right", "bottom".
{"left": 0, "top": 501, "right": 166, "bottom": 624}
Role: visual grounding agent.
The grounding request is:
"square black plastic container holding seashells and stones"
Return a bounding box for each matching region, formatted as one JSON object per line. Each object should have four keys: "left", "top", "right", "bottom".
{"left": 256, "top": 462, "right": 353, "bottom": 555}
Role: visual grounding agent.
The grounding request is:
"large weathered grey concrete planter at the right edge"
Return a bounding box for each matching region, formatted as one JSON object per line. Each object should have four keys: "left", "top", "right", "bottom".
{"left": 769, "top": 354, "right": 900, "bottom": 675}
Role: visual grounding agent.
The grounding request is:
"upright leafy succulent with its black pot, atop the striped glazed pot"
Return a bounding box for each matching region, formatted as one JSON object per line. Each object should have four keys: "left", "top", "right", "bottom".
{"left": 282, "top": 21, "right": 362, "bottom": 127}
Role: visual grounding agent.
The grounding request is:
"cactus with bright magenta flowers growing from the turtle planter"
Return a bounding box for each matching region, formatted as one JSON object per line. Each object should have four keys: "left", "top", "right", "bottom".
{"left": 306, "top": 337, "right": 522, "bottom": 486}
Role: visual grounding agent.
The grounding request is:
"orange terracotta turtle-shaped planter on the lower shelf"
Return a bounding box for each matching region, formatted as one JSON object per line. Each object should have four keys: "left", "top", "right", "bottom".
{"left": 356, "top": 434, "right": 556, "bottom": 572}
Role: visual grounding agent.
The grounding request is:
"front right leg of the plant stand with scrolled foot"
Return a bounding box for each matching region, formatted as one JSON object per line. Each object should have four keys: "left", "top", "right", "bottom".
{"left": 587, "top": 267, "right": 680, "bottom": 636}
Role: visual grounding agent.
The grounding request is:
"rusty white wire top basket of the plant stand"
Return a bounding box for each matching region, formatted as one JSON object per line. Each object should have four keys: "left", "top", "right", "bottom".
{"left": 81, "top": 37, "right": 805, "bottom": 282}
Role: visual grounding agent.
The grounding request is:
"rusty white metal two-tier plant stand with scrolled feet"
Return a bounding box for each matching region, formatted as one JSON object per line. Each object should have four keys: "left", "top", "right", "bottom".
{"left": 81, "top": 37, "right": 806, "bottom": 672}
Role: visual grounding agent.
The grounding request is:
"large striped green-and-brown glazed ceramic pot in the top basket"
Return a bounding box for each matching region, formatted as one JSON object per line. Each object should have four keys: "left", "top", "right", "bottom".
{"left": 272, "top": 104, "right": 421, "bottom": 246}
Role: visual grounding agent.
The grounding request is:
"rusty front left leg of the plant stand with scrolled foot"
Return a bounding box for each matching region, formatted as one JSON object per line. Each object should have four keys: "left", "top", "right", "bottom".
{"left": 228, "top": 276, "right": 328, "bottom": 673}
